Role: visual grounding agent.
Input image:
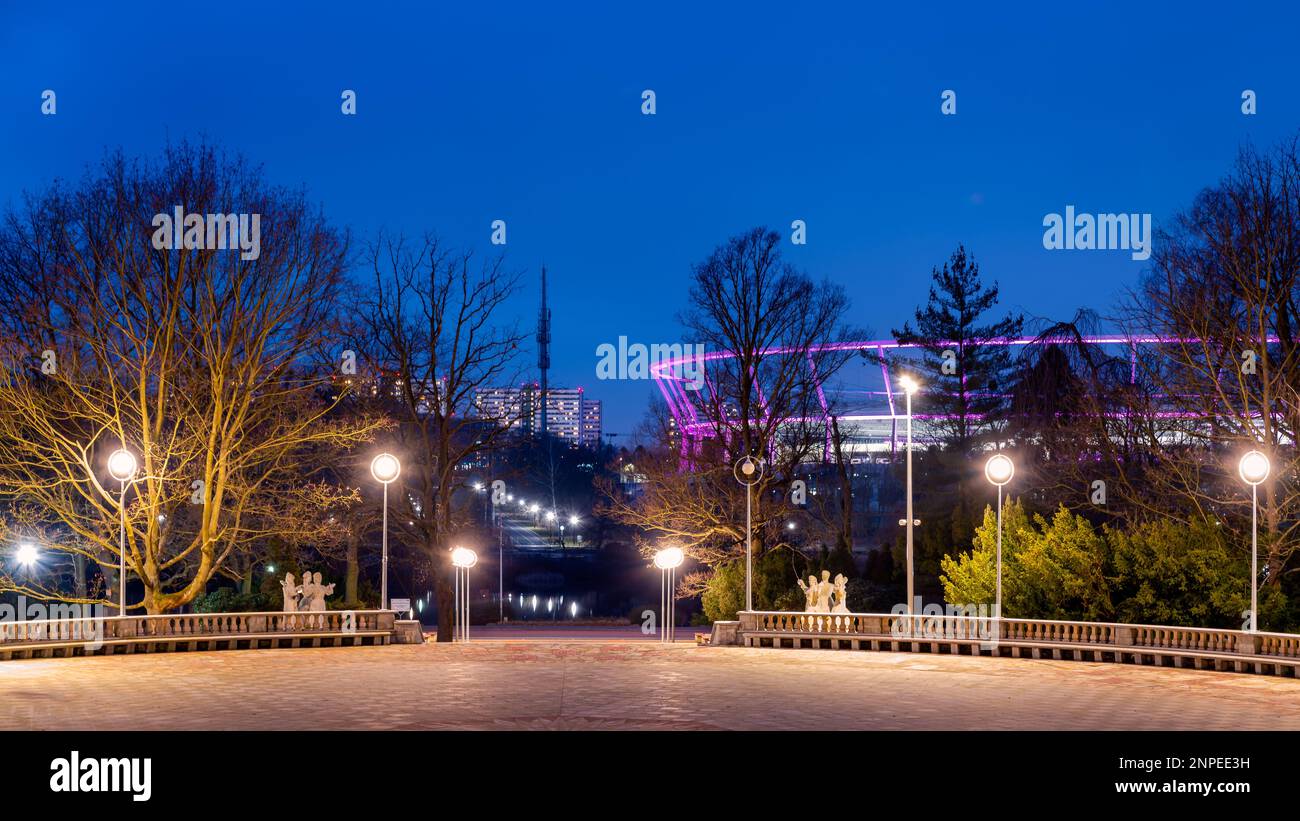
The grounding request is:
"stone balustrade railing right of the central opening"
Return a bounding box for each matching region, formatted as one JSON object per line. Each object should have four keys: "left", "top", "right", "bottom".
{"left": 736, "top": 611, "right": 1300, "bottom": 676}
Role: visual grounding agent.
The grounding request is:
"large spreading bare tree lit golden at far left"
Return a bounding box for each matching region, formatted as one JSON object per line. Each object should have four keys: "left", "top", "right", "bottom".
{"left": 0, "top": 144, "right": 377, "bottom": 613}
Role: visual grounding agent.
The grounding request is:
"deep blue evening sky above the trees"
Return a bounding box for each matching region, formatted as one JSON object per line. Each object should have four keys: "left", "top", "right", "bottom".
{"left": 0, "top": 0, "right": 1300, "bottom": 433}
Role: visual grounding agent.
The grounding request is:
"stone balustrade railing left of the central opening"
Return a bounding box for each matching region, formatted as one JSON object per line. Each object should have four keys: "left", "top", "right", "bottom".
{"left": 0, "top": 611, "right": 397, "bottom": 659}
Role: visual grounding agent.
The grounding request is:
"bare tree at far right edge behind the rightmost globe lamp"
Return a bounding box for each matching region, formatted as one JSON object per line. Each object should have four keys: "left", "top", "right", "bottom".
{"left": 1123, "top": 140, "right": 1300, "bottom": 585}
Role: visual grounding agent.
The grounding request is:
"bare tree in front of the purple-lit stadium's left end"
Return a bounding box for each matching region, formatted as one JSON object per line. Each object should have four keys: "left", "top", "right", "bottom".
{"left": 607, "top": 229, "right": 852, "bottom": 605}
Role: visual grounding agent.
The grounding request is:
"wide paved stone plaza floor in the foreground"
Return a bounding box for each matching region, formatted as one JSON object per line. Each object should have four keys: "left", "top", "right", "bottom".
{"left": 0, "top": 640, "right": 1300, "bottom": 730}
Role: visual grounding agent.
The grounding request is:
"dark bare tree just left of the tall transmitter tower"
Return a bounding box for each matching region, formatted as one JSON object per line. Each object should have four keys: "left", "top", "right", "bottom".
{"left": 351, "top": 236, "right": 525, "bottom": 642}
